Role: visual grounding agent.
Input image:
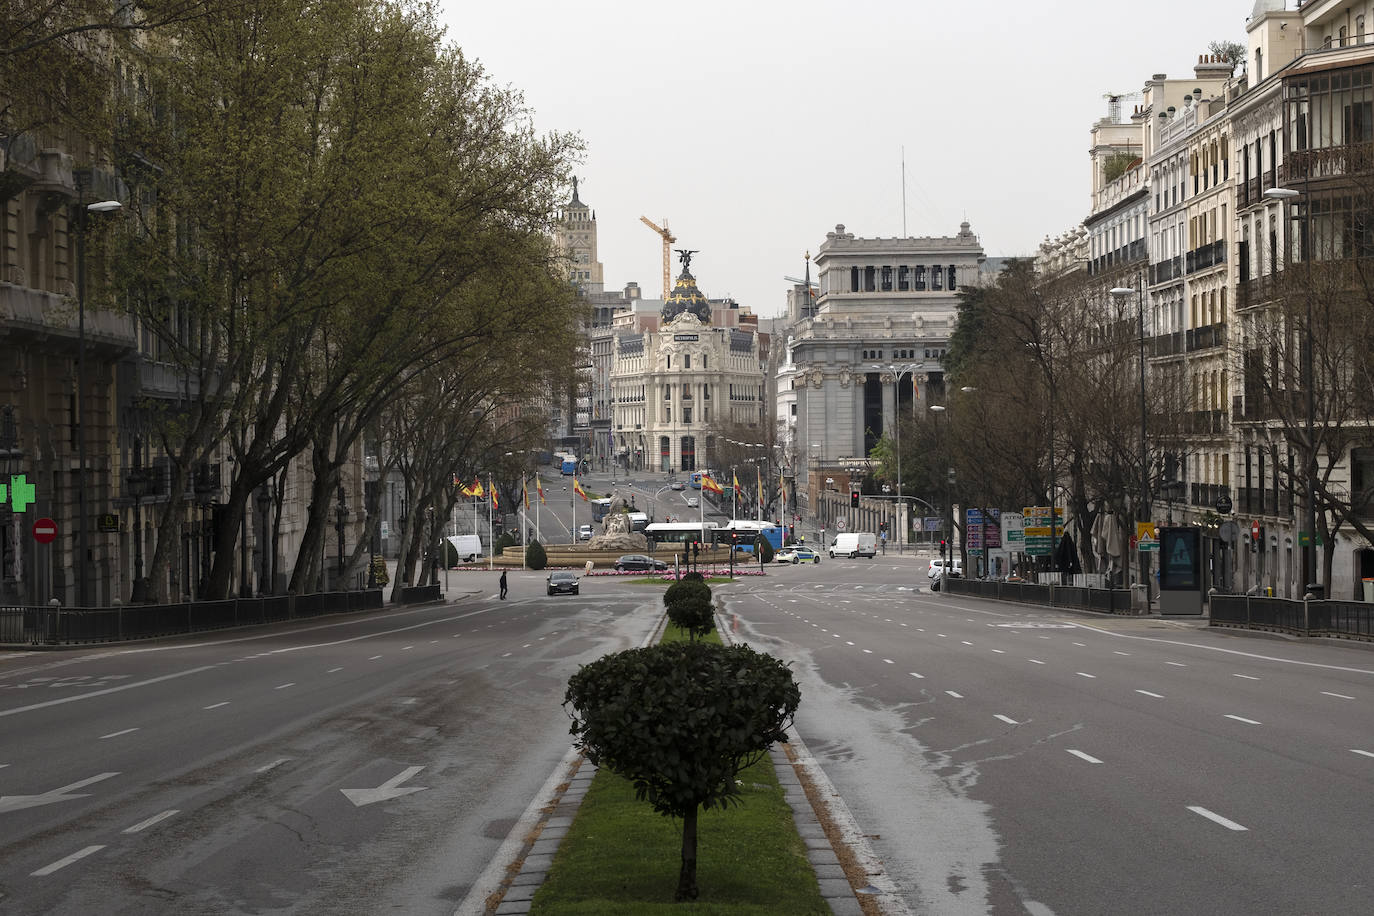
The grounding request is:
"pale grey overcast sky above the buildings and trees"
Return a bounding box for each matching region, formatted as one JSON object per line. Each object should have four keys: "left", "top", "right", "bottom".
{"left": 442, "top": 0, "right": 1253, "bottom": 317}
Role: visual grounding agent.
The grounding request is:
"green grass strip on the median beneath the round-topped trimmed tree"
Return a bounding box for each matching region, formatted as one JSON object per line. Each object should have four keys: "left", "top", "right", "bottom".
{"left": 530, "top": 626, "right": 830, "bottom": 916}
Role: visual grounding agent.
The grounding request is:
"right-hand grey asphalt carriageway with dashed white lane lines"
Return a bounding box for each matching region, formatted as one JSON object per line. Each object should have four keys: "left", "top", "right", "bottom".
{"left": 727, "top": 558, "right": 1374, "bottom": 916}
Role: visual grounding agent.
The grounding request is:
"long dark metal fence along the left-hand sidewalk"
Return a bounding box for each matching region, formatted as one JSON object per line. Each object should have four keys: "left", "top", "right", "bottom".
{"left": 0, "top": 589, "right": 382, "bottom": 645}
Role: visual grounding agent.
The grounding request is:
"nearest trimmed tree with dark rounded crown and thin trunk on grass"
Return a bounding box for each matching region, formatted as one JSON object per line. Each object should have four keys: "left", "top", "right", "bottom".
{"left": 563, "top": 641, "right": 801, "bottom": 901}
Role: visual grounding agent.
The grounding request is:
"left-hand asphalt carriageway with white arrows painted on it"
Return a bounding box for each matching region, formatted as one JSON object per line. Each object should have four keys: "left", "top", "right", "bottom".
{"left": 0, "top": 571, "right": 660, "bottom": 916}
